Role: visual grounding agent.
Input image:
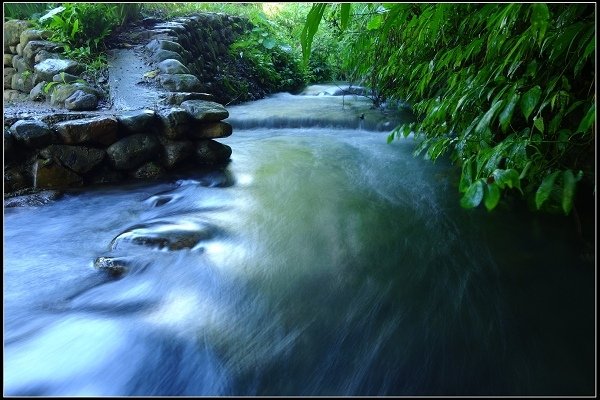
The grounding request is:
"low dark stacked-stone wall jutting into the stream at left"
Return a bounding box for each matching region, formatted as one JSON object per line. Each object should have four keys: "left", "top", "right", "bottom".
{"left": 4, "top": 100, "right": 232, "bottom": 193}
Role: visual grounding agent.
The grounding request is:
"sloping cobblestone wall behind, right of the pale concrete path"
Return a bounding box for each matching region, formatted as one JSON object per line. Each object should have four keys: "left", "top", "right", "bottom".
{"left": 141, "top": 13, "right": 268, "bottom": 104}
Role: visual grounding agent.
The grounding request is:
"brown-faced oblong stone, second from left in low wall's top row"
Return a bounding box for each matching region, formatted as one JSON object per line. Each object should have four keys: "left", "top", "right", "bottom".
{"left": 54, "top": 116, "right": 118, "bottom": 146}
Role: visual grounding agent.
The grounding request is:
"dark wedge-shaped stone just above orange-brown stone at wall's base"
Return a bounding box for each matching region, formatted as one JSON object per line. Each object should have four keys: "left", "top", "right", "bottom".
{"left": 40, "top": 145, "right": 106, "bottom": 174}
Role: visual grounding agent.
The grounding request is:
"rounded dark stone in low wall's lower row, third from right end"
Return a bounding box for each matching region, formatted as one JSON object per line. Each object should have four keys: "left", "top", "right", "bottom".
{"left": 106, "top": 133, "right": 160, "bottom": 170}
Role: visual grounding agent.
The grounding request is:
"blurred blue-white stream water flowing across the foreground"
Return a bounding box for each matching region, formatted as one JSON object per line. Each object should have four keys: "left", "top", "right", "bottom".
{"left": 4, "top": 86, "right": 595, "bottom": 396}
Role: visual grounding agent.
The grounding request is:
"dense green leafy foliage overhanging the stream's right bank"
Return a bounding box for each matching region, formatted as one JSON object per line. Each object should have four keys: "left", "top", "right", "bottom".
{"left": 302, "top": 3, "right": 596, "bottom": 214}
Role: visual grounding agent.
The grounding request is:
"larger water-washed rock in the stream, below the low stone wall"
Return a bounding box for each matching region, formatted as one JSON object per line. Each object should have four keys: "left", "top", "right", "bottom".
{"left": 110, "top": 220, "right": 217, "bottom": 250}
